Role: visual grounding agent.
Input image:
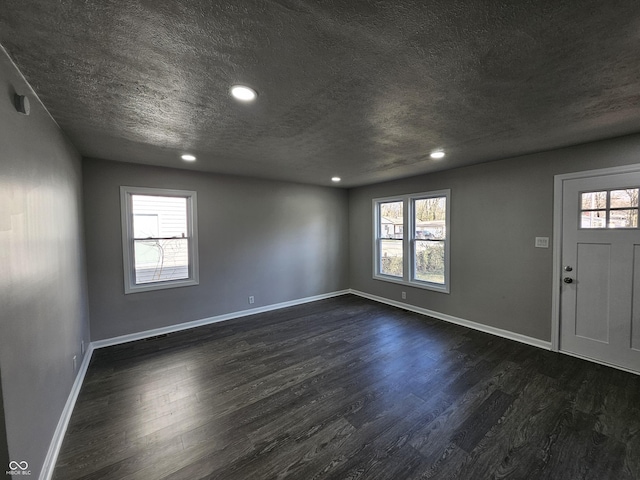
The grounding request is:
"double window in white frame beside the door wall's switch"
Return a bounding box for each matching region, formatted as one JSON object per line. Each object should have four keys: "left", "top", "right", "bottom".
{"left": 373, "top": 190, "right": 450, "bottom": 293}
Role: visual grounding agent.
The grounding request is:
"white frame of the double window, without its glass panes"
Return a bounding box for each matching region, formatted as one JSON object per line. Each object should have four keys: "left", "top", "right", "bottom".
{"left": 372, "top": 189, "right": 451, "bottom": 293}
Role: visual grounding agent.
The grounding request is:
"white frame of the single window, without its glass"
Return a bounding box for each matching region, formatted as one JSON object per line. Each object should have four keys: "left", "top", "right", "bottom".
{"left": 120, "top": 186, "right": 200, "bottom": 294}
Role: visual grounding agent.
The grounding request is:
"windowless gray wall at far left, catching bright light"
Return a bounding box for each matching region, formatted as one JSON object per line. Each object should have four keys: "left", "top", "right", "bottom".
{"left": 0, "top": 48, "right": 89, "bottom": 478}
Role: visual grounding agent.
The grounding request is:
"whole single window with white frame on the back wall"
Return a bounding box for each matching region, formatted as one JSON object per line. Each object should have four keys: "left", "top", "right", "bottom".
{"left": 120, "top": 187, "right": 198, "bottom": 293}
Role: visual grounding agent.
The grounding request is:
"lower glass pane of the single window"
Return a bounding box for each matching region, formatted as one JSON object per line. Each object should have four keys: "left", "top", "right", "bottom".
{"left": 134, "top": 238, "right": 189, "bottom": 285}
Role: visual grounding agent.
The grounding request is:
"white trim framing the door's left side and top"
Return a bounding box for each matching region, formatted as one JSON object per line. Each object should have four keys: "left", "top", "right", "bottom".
{"left": 551, "top": 164, "right": 640, "bottom": 352}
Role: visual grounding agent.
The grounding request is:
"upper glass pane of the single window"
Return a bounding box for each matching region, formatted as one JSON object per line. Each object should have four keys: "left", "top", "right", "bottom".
{"left": 131, "top": 195, "right": 187, "bottom": 238}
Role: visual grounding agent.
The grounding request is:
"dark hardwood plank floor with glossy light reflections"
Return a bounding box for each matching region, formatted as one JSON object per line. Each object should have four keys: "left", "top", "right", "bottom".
{"left": 54, "top": 295, "right": 640, "bottom": 480}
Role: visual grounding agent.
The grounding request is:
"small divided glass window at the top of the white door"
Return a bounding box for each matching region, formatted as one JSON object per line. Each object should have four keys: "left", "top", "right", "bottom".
{"left": 580, "top": 188, "right": 638, "bottom": 229}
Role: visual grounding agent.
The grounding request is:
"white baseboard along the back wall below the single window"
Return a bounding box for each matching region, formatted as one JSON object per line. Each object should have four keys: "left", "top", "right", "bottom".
{"left": 91, "top": 290, "right": 349, "bottom": 348}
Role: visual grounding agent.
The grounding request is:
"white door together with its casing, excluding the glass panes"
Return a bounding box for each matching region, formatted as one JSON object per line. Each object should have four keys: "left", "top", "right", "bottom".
{"left": 552, "top": 166, "right": 640, "bottom": 373}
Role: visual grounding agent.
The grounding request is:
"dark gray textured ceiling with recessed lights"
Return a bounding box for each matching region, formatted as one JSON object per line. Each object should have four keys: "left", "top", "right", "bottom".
{"left": 0, "top": 0, "right": 640, "bottom": 186}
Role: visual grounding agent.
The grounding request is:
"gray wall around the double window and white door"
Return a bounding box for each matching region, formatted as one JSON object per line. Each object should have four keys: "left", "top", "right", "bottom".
{"left": 349, "top": 136, "right": 640, "bottom": 341}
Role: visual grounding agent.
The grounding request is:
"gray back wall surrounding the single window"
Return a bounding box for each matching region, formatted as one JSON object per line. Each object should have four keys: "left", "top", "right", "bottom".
{"left": 83, "top": 159, "right": 348, "bottom": 340}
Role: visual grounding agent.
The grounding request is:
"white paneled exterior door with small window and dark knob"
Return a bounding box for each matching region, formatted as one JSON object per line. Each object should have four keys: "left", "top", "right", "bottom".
{"left": 559, "top": 172, "right": 640, "bottom": 372}
